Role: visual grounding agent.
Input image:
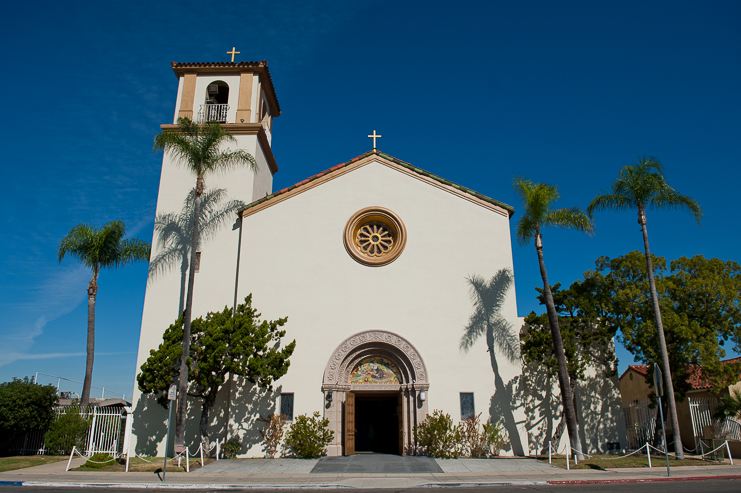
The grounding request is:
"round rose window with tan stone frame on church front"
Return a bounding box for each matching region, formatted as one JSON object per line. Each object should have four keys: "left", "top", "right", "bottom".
{"left": 344, "top": 207, "right": 406, "bottom": 266}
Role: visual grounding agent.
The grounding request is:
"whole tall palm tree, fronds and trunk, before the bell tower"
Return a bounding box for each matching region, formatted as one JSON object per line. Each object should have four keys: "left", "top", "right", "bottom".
{"left": 154, "top": 118, "right": 257, "bottom": 453}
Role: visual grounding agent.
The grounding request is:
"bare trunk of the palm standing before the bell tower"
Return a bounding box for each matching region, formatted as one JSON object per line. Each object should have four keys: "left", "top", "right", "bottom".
{"left": 175, "top": 180, "right": 203, "bottom": 453}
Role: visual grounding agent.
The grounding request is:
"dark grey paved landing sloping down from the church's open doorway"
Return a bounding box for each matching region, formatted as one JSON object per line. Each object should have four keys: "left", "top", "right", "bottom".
{"left": 311, "top": 453, "right": 443, "bottom": 474}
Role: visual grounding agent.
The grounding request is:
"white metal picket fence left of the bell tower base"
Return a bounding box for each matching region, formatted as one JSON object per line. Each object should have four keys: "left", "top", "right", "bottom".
{"left": 10, "top": 406, "right": 132, "bottom": 456}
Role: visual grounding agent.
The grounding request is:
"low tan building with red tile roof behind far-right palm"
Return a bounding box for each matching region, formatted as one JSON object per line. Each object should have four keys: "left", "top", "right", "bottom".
{"left": 620, "top": 358, "right": 741, "bottom": 448}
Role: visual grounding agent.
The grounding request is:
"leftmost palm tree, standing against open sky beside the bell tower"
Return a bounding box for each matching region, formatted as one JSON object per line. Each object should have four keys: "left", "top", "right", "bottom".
{"left": 57, "top": 221, "right": 150, "bottom": 407}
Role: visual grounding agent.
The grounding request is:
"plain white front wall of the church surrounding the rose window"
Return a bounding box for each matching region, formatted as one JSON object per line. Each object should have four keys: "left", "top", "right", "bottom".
{"left": 238, "top": 163, "right": 526, "bottom": 455}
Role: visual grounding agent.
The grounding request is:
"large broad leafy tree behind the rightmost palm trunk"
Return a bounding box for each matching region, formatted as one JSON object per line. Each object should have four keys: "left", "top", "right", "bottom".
{"left": 586, "top": 251, "right": 741, "bottom": 403}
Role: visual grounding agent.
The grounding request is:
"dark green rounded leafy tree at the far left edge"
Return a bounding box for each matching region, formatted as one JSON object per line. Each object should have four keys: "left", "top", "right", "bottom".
{"left": 0, "top": 377, "right": 59, "bottom": 449}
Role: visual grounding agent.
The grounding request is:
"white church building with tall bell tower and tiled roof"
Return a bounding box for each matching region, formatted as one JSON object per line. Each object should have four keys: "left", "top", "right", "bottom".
{"left": 132, "top": 61, "right": 624, "bottom": 457}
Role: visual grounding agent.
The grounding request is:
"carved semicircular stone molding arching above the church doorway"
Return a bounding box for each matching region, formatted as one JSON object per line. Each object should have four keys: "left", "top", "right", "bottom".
{"left": 322, "top": 330, "right": 430, "bottom": 391}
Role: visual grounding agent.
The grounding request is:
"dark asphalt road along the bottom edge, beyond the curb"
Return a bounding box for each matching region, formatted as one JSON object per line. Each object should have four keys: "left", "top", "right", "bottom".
{"left": 0, "top": 479, "right": 741, "bottom": 493}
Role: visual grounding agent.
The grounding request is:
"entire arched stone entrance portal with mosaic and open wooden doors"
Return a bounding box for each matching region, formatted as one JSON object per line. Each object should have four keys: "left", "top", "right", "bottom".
{"left": 322, "top": 330, "right": 430, "bottom": 456}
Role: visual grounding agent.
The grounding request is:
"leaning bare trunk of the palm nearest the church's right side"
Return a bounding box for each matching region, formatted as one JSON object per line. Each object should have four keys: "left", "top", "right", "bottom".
{"left": 535, "top": 232, "right": 584, "bottom": 460}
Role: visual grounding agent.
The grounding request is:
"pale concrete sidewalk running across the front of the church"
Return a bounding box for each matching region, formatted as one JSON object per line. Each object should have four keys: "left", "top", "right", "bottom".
{"left": 0, "top": 459, "right": 741, "bottom": 489}
